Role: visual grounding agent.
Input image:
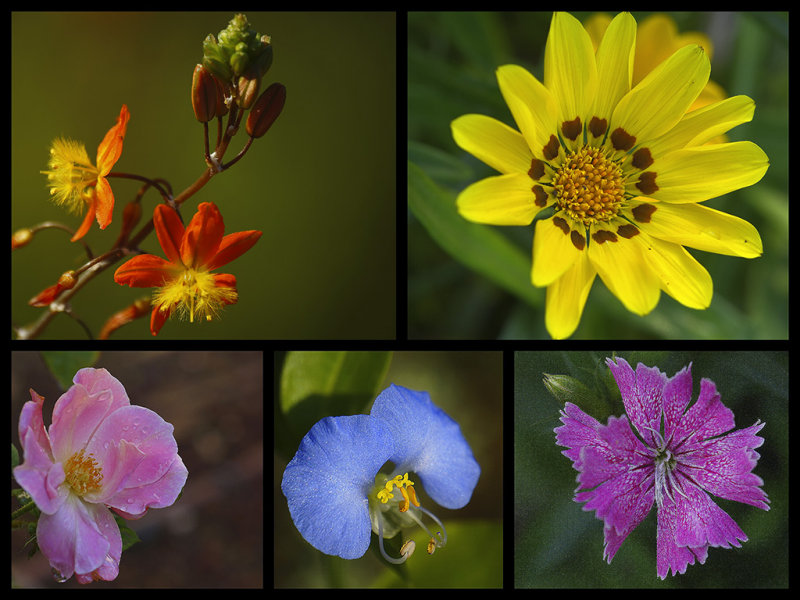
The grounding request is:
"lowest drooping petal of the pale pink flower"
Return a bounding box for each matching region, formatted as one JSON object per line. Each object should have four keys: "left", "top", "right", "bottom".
{"left": 36, "top": 494, "right": 122, "bottom": 578}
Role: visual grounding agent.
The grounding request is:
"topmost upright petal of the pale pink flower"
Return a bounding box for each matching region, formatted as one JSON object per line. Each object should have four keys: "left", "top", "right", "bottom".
{"left": 50, "top": 368, "right": 130, "bottom": 462}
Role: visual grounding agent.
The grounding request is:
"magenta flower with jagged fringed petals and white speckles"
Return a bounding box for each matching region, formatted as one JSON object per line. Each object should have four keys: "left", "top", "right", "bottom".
{"left": 554, "top": 358, "right": 769, "bottom": 579}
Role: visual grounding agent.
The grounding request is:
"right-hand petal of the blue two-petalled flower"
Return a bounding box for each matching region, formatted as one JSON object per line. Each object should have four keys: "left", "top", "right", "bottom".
{"left": 370, "top": 384, "right": 481, "bottom": 508}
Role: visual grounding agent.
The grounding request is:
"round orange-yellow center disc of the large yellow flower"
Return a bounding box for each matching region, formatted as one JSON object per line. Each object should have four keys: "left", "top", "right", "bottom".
{"left": 553, "top": 146, "right": 625, "bottom": 227}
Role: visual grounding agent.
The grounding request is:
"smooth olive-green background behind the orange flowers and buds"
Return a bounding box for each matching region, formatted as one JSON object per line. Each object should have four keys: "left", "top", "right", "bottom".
{"left": 11, "top": 12, "right": 396, "bottom": 339}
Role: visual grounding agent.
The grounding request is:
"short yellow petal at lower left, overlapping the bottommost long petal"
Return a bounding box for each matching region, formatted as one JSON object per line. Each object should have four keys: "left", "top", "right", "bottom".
{"left": 531, "top": 213, "right": 586, "bottom": 287}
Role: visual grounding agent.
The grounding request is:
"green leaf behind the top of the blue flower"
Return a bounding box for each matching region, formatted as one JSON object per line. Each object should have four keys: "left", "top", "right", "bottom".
{"left": 280, "top": 352, "right": 392, "bottom": 434}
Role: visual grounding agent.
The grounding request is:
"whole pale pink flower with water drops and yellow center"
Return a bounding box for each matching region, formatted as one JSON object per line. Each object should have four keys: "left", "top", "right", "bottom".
{"left": 14, "top": 369, "right": 188, "bottom": 583}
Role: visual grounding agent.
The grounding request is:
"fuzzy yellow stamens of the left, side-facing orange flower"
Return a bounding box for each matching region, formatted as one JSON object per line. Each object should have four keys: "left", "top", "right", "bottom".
{"left": 42, "top": 138, "right": 99, "bottom": 214}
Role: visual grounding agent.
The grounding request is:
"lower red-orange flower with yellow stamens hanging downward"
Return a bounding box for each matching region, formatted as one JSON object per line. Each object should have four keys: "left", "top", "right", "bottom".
{"left": 114, "top": 202, "right": 261, "bottom": 335}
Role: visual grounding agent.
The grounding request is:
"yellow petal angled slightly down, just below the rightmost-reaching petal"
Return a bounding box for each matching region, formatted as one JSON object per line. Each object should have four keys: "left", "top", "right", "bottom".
{"left": 624, "top": 198, "right": 763, "bottom": 258}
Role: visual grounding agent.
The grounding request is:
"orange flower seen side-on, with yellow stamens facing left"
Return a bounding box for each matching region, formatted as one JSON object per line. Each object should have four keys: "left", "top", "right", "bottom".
{"left": 42, "top": 104, "right": 131, "bottom": 242}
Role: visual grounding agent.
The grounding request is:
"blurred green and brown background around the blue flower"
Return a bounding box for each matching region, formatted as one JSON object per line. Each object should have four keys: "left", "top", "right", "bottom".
{"left": 273, "top": 352, "right": 500, "bottom": 588}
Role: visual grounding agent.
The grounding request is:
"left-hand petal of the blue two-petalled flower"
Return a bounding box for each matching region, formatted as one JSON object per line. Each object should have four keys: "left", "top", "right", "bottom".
{"left": 281, "top": 415, "right": 393, "bottom": 559}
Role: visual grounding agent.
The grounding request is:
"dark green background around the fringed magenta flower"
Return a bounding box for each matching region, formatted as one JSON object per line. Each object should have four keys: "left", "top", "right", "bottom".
{"left": 514, "top": 351, "right": 789, "bottom": 588}
